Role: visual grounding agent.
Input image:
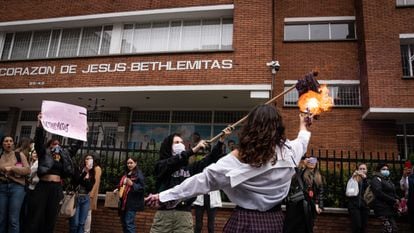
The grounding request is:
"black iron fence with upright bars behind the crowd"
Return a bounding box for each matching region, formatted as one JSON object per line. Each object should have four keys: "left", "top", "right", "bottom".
{"left": 71, "top": 145, "right": 405, "bottom": 207}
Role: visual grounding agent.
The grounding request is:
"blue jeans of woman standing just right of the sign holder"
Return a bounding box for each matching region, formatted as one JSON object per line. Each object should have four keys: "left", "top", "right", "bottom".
{"left": 69, "top": 194, "right": 90, "bottom": 233}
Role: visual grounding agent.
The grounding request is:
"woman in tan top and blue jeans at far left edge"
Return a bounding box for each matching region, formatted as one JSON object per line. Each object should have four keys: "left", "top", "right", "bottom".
{"left": 0, "top": 136, "right": 30, "bottom": 233}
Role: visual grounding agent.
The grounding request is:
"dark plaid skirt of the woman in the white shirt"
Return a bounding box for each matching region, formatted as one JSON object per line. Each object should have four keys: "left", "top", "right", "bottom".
{"left": 223, "top": 206, "right": 284, "bottom": 233}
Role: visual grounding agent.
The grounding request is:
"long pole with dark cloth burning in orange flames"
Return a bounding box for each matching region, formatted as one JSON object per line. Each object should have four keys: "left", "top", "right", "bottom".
{"left": 207, "top": 71, "right": 332, "bottom": 143}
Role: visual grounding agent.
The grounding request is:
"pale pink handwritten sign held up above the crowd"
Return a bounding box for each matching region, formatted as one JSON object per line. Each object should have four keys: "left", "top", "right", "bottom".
{"left": 42, "top": 100, "right": 88, "bottom": 141}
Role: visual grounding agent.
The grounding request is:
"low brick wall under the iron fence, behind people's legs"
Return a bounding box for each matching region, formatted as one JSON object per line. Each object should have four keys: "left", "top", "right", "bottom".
{"left": 55, "top": 201, "right": 409, "bottom": 233}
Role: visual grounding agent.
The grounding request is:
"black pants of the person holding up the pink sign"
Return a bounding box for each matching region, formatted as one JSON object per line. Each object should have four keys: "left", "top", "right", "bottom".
{"left": 24, "top": 181, "right": 63, "bottom": 233}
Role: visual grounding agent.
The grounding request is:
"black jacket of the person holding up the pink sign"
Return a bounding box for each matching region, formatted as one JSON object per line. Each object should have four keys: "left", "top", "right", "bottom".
{"left": 34, "top": 127, "right": 82, "bottom": 178}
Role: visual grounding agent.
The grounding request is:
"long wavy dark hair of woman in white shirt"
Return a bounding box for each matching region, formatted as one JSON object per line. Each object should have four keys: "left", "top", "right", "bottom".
{"left": 239, "top": 104, "right": 285, "bottom": 167}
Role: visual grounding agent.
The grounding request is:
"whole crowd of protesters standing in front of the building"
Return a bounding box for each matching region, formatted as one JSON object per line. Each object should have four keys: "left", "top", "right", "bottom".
{"left": 0, "top": 105, "right": 414, "bottom": 233}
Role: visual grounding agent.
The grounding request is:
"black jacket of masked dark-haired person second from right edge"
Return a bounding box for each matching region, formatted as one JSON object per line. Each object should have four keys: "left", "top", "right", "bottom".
{"left": 371, "top": 173, "right": 398, "bottom": 217}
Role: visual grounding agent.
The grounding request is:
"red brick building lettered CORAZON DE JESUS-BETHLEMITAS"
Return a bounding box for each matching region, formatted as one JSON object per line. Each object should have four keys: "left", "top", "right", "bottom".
{"left": 0, "top": 0, "right": 414, "bottom": 158}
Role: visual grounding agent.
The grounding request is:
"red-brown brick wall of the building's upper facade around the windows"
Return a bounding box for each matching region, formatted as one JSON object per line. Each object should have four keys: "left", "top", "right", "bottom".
{"left": 0, "top": 0, "right": 414, "bottom": 153}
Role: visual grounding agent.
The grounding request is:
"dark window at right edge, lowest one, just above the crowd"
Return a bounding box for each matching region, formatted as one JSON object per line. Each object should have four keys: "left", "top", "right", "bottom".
{"left": 397, "top": 124, "right": 414, "bottom": 160}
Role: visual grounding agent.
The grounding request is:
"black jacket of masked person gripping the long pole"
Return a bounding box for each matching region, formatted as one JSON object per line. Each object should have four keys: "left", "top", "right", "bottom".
{"left": 155, "top": 134, "right": 223, "bottom": 211}
